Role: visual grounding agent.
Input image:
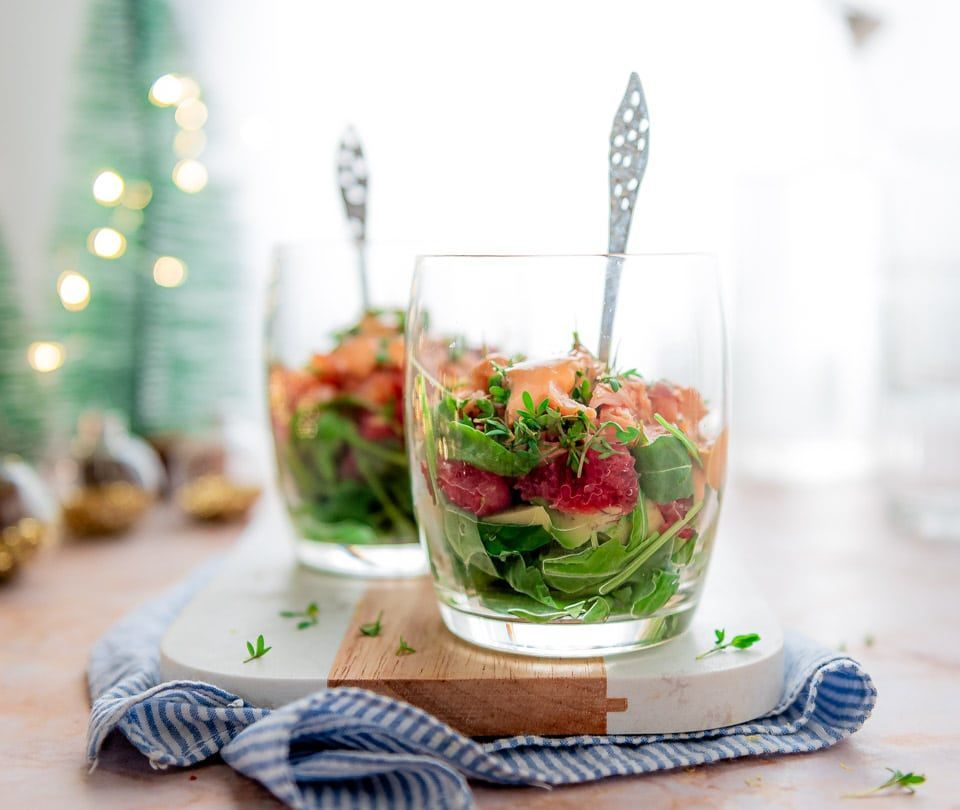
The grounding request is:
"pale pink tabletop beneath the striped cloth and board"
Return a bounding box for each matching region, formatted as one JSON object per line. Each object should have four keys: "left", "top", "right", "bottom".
{"left": 0, "top": 486, "right": 960, "bottom": 810}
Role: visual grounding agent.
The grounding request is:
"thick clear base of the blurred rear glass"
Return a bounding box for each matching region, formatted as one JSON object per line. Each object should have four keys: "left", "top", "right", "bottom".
{"left": 296, "top": 539, "right": 429, "bottom": 579}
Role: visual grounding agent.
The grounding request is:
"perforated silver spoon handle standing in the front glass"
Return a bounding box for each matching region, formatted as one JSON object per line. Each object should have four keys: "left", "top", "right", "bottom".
{"left": 599, "top": 73, "right": 650, "bottom": 363}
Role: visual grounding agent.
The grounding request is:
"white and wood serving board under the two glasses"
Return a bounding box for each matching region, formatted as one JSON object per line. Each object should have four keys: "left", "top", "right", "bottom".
{"left": 160, "top": 507, "right": 783, "bottom": 736}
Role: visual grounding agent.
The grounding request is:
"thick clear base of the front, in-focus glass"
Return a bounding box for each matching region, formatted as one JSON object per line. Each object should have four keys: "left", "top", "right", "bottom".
{"left": 440, "top": 602, "right": 696, "bottom": 658}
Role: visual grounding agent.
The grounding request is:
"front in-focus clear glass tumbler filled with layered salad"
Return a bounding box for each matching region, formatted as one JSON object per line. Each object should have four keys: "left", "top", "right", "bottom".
{"left": 406, "top": 255, "right": 727, "bottom": 656}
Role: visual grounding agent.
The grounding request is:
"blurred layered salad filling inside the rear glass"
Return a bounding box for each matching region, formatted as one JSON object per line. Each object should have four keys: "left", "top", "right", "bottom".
{"left": 270, "top": 313, "right": 416, "bottom": 545}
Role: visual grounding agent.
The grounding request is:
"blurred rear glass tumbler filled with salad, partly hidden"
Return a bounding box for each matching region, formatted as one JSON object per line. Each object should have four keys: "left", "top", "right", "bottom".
{"left": 267, "top": 242, "right": 426, "bottom": 577}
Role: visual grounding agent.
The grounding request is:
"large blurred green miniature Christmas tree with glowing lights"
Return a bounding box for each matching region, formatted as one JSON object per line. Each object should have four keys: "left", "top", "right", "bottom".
{"left": 51, "top": 0, "right": 243, "bottom": 434}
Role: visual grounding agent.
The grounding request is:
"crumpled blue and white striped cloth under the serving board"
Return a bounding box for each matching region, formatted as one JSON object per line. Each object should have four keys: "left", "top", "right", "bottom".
{"left": 87, "top": 567, "right": 877, "bottom": 809}
